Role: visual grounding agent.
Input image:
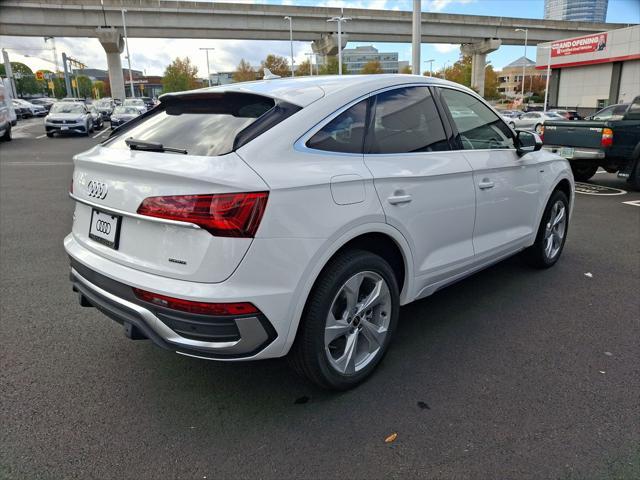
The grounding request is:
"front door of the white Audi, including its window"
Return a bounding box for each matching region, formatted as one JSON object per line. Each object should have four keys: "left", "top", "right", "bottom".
{"left": 440, "top": 87, "right": 540, "bottom": 258}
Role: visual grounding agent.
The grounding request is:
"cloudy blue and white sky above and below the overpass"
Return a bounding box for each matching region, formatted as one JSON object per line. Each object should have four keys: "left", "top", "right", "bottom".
{"left": 0, "top": 0, "right": 640, "bottom": 77}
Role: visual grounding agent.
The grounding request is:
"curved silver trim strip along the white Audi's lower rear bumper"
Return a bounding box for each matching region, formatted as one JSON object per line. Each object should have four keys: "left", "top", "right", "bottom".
{"left": 71, "top": 268, "right": 269, "bottom": 358}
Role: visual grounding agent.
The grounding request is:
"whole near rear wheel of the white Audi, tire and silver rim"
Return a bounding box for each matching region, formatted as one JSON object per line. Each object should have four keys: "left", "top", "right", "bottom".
{"left": 289, "top": 250, "right": 400, "bottom": 390}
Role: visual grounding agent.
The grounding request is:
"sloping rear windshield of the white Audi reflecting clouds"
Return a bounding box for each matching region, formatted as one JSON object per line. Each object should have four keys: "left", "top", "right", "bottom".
{"left": 105, "top": 92, "right": 299, "bottom": 156}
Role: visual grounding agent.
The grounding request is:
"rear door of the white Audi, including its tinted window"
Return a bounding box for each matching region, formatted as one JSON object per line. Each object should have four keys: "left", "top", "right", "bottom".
{"left": 364, "top": 86, "right": 475, "bottom": 294}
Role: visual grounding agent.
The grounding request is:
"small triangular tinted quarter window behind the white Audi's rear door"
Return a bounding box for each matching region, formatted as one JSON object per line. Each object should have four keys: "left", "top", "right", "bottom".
{"left": 307, "top": 100, "right": 367, "bottom": 153}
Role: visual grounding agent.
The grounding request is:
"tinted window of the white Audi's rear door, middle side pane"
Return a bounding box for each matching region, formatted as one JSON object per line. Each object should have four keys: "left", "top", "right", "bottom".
{"left": 367, "top": 87, "right": 449, "bottom": 153}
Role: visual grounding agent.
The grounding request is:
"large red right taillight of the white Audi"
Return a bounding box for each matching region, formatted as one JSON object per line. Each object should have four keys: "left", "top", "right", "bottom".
{"left": 138, "top": 192, "right": 269, "bottom": 238}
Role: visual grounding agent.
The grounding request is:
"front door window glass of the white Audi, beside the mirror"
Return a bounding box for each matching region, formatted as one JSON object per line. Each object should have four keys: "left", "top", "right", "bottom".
{"left": 441, "top": 88, "right": 516, "bottom": 150}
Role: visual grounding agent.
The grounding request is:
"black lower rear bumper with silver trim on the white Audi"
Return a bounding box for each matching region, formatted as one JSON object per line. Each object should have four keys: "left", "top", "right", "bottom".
{"left": 70, "top": 258, "right": 277, "bottom": 359}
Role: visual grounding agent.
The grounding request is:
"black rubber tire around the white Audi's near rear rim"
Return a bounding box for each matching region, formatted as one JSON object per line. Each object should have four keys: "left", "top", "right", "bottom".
{"left": 288, "top": 250, "right": 400, "bottom": 390}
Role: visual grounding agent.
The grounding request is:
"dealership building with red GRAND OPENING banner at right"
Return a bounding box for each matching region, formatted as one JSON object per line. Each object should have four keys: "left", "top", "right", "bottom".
{"left": 536, "top": 25, "right": 640, "bottom": 114}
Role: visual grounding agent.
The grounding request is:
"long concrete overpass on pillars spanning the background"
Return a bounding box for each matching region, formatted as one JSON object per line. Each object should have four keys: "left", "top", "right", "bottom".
{"left": 0, "top": 0, "right": 626, "bottom": 96}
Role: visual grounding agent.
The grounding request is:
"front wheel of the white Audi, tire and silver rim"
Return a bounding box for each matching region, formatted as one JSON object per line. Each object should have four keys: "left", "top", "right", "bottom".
{"left": 522, "top": 190, "right": 569, "bottom": 268}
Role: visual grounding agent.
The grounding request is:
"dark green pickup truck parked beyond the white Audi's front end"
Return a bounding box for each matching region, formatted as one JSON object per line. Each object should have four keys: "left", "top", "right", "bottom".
{"left": 542, "top": 96, "right": 640, "bottom": 190}
